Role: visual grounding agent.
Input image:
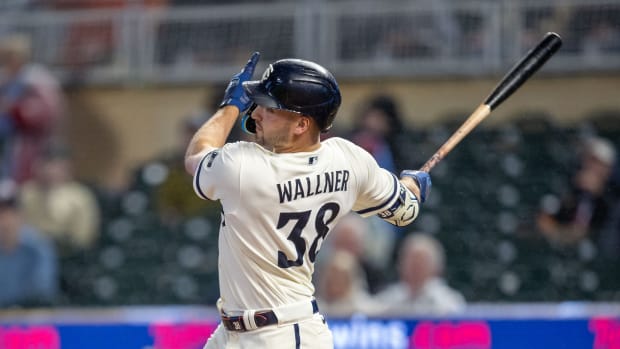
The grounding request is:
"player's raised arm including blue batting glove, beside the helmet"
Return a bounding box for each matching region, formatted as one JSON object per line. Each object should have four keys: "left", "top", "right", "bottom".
{"left": 185, "top": 52, "right": 259, "bottom": 175}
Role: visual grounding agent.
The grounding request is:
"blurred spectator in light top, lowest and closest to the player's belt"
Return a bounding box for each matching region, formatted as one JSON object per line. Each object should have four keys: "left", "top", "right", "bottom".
{"left": 317, "top": 250, "right": 380, "bottom": 317}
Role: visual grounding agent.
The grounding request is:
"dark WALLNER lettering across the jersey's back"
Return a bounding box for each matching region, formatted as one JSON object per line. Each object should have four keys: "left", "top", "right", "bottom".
{"left": 277, "top": 170, "right": 349, "bottom": 203}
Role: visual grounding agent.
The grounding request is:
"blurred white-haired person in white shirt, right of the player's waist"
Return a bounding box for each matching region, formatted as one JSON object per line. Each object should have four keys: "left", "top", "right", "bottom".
{"left": 375, "top": 233, "right": 466, "bottom": 316}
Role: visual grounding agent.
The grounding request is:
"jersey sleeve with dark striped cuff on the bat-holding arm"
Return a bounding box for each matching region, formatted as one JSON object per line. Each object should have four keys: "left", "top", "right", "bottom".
{"left": 352, "top": 140, "right": 400, "bottom": 217}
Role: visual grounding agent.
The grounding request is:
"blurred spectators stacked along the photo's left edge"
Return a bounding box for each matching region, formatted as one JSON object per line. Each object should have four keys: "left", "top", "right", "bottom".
{"left": 0, "top": 34, "right": 100, "bottom": 306}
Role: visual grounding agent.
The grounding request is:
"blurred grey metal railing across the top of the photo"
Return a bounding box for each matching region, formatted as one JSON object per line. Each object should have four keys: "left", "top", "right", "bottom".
{"left": 0, "top": 0, "right": 620, "bottom": 84}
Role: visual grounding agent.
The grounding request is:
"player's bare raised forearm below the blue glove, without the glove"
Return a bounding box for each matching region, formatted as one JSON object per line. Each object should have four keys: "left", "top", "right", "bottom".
{"left": 185, "top": 105, "right": 239, "bottom": 175}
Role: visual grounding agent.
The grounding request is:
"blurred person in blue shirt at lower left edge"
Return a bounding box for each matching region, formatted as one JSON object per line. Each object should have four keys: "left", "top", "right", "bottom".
{"left": 0, "top": 179, "right": 58, "bottom": 307}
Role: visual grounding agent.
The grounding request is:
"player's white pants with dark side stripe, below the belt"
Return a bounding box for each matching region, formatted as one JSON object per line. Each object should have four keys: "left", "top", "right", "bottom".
{"left": 204, "top": 313, "right": 334, "bottom": 349}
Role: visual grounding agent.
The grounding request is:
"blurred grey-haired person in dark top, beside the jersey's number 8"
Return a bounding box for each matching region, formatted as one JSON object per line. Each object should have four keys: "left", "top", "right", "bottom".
{"left": 326, "top": 213, "right": 385, "bottom": 294}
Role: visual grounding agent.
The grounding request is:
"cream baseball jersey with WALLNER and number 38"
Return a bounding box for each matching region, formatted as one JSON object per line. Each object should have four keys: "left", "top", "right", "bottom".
{"left": 194, "top": 137, "right": 399, "bottom": 311}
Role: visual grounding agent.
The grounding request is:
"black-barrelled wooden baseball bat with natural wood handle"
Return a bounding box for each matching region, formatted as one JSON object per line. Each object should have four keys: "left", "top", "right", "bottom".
{"left": 420, "top": 32, "right": 562, "bottom": 172}
